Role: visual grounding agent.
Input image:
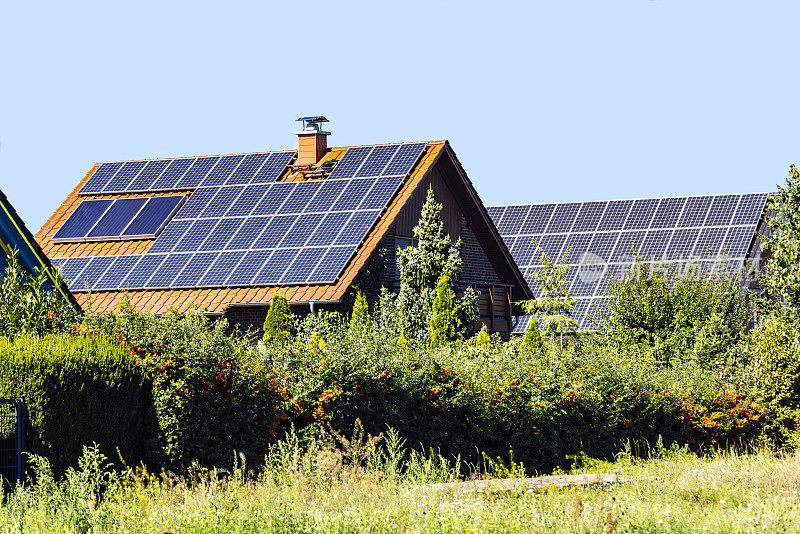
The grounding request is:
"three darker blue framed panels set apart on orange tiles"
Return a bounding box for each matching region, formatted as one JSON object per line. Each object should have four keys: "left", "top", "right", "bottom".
{"left": 53, "top": 195, "right": 186, "bottom": 243}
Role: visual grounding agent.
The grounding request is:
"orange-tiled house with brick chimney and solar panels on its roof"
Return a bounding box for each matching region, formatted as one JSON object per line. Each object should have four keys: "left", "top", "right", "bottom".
{"left": 36, "top": 117, "right": 532, "bottom": 333}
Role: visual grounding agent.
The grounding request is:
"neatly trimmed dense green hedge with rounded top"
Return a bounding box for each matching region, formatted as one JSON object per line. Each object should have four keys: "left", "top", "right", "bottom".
{"left": 0, "top": 335, "right": 156, "bottom": 473}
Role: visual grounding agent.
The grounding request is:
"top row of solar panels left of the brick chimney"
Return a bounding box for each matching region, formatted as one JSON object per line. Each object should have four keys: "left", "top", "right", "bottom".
{"left": 78, "top": 150, "right": 297, "bottom": 195}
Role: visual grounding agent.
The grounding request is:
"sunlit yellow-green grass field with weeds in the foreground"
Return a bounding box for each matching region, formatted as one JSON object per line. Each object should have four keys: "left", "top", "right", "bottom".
{"left": 0, "top": 451, "right": 800, "bottom": 533}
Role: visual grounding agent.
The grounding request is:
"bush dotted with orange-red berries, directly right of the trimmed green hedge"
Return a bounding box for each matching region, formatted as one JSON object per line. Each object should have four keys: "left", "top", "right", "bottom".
{"left": 86, "top": 310, "right": 285, "bottom": 471}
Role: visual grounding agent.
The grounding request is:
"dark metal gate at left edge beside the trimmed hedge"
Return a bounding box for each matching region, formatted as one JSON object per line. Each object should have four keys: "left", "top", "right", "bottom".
{"left": 0, "top": 398, "right": 26, "bottom": 494}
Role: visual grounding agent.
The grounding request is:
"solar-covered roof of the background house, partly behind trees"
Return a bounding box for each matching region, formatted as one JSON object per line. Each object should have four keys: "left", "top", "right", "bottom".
{"left": 488, "top": 193, "right": 769, "bottom": 333}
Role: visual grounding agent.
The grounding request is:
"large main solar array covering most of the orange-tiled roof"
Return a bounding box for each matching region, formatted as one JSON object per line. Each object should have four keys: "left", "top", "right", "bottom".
{"left": 55, "top": 143, "right": 426, "bottom": 291}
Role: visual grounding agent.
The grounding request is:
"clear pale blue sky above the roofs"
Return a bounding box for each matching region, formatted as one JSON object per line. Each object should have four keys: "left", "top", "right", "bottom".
{"left": 0, "top": 0, "right": 800, "bottom": 232}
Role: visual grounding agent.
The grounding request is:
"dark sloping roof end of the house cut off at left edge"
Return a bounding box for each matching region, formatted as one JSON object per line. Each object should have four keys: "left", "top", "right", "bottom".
{"left": 0, "top": 191, "right": 77, "bottom": 306}
